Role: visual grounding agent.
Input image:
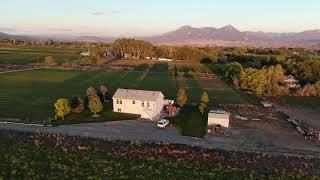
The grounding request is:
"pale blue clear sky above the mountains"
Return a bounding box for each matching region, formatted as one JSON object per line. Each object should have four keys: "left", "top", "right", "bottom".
{"left": 0, "top": 0, "right": 320, "bottom": 36}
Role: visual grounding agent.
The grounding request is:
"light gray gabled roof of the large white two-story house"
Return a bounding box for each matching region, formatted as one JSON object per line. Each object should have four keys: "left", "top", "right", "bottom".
{"left": 112, "top": 89, "right": 164, "bottom": 101}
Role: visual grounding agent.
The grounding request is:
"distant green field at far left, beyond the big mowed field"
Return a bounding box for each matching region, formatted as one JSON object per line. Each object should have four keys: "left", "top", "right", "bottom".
{"left": 0, "top": 48, "right": 82, "bottom": 63}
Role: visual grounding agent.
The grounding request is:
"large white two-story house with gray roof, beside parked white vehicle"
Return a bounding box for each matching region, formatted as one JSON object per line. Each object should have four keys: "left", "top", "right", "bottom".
{"left": 112, "top": 89, "right": 164, "bottom": 120}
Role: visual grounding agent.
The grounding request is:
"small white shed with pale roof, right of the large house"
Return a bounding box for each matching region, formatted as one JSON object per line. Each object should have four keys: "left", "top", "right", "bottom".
{"left": 208, "top": 110, "right": 230, "bottom": 128}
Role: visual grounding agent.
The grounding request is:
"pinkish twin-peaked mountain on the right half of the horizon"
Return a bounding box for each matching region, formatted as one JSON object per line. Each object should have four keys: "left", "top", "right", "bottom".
{"left": 144, "top": 25, "right": 320, "bottom": 47}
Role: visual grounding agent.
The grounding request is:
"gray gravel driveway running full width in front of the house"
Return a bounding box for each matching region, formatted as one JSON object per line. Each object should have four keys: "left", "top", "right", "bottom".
{"left": 0, "top": 120, "right": 320, "bottom": 157}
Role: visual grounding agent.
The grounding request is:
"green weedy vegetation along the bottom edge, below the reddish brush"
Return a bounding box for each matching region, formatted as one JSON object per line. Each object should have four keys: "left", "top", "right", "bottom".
{"left": 0, "top": 143, "right": 285, "bottom": 179}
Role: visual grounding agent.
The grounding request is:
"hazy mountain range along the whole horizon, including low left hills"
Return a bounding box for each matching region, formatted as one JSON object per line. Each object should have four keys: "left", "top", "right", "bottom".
{"left": 0, "top": 25, "right": 320, "bottom": 48}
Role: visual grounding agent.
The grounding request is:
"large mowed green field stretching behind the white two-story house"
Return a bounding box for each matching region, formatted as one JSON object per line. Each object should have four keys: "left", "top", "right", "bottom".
{"left": 0, "top": 70, "right": 253, "bottom": 132}
